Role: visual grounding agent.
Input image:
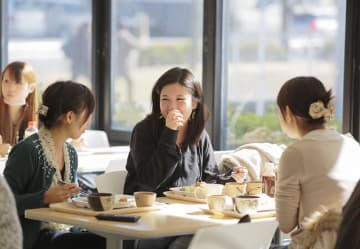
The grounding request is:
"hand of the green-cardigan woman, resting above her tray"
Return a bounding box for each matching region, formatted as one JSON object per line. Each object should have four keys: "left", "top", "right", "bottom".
{"left": 44, "top": 183, "right": 80, "bottom": 204}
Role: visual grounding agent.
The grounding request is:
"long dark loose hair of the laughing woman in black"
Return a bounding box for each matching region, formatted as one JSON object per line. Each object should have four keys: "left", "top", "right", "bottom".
{"left": 148, "top": 67, "right": 209, "bottom": 148}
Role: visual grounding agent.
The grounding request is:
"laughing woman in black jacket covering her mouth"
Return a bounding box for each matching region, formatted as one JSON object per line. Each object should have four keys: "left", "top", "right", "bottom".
{"left": 124, "top": 67, "right": 247, "bottom": 248}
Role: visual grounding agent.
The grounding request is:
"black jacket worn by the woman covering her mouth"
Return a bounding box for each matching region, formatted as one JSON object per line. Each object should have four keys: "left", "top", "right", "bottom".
{"left": 124, "top": 117, "right": 218, "bottom": 196}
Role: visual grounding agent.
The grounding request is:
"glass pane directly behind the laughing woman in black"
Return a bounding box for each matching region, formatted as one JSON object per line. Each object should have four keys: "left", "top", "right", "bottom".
{"left": 111, "top": 0, "right": 203, "bottom": 130}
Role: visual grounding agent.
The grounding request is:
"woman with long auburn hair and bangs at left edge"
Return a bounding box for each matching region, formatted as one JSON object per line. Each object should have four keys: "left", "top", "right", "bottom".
{"left": 0, "top": 61, "right": 37, "bottom": 156}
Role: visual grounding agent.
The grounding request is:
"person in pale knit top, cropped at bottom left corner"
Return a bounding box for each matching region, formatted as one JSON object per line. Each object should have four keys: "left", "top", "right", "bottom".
{"left": 0, "top": 175, "right": 22, "bottom": 249}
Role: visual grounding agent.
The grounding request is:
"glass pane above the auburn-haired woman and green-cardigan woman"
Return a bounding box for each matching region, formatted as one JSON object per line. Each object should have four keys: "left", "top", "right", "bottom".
{"left": 7, "top": 0, "right": 91, "bottom": 91}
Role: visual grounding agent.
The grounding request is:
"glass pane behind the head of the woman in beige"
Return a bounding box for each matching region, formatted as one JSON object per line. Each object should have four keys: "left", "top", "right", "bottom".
{"left": 224, "top": 0, "right": 346, "bottom": 148}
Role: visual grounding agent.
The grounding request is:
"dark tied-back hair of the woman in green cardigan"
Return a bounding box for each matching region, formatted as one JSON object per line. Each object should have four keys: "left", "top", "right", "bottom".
{"left": 39, "top": 81, "right": 95, "bottom": 129}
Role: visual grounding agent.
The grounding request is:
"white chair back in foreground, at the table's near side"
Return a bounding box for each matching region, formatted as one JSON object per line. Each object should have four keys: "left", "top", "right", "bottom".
{"left": 188, "top": 220, "right": 278, "bottom": 249}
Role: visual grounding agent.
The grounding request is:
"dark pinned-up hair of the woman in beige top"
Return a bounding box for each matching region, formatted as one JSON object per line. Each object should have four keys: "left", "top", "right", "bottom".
{"left": 277, "top": 76, "right": 333, "bottom": 125}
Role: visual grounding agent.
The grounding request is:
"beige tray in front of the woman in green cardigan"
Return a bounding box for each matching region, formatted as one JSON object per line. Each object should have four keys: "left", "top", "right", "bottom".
{"left": 50, "top": 202, "right": 160, "bottom": 216}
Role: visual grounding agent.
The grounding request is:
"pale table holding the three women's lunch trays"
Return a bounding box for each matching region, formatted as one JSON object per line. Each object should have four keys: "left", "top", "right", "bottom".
{"left": 25, "top": 198, "right": 274, "bottom": 249}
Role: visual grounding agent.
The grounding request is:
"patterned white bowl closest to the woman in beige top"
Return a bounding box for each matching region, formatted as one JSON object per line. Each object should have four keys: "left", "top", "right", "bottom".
{"left": 233, "top": 195, "right": 260, "bottom": 214}
